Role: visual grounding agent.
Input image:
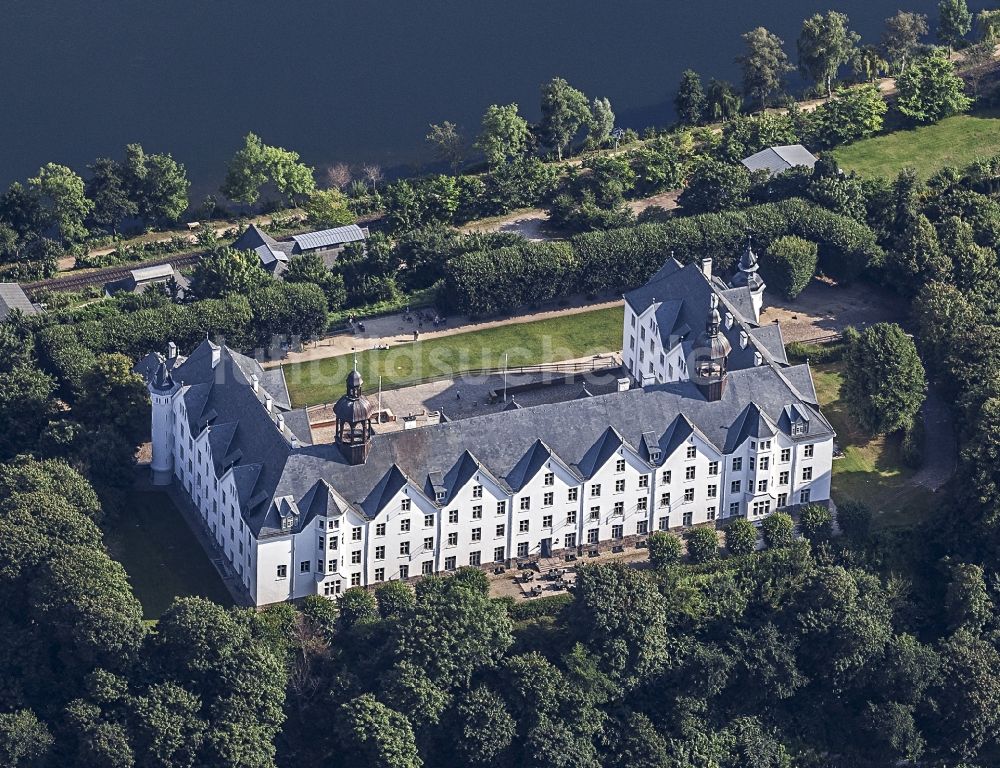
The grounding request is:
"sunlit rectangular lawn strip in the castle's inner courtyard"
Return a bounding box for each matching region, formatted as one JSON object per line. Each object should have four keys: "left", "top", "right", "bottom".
{"left": 285, "top": 307, "right": 623, "bottom": 407}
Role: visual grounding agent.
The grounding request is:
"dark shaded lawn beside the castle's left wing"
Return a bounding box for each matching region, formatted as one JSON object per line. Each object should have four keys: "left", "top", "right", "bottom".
{"left": 104, "top": 491, "right": 232, "bottom": 620}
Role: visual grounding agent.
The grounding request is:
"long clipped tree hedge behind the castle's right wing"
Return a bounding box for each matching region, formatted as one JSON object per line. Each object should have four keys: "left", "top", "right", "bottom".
{"left": 442, "top": 199, "right": 885, "bottom": 316}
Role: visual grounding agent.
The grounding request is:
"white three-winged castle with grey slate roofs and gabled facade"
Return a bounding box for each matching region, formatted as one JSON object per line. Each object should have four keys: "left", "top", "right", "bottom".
{"left": 137, "top": 246, "right": 834, "bottom": 605}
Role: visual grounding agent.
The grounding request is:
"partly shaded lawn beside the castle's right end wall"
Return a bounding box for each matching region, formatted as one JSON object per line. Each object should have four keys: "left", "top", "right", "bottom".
{"left": 813, "top": 363, "right": 931, "bottom": 527}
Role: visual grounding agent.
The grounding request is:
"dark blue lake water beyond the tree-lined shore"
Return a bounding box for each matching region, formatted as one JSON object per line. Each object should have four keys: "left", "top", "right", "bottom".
{"left": 0, "top": 0, "right": 981, "bottom": 194}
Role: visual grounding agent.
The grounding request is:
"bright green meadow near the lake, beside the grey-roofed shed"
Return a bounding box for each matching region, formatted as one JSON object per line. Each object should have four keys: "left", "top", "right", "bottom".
{"left": 833, "top": 110, "right": 1000, "bottom": 179}
